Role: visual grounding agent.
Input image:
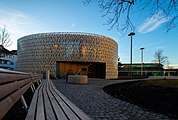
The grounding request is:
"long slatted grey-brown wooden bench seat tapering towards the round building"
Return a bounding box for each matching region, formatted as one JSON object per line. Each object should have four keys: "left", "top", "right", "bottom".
{"left": 26, "top": 80, "right": 91, "bottom": 120}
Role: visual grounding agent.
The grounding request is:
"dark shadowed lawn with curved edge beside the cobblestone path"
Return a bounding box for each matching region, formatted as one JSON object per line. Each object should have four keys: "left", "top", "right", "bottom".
{"left": 103, "top": 80, "right": 178, "bottom": 119}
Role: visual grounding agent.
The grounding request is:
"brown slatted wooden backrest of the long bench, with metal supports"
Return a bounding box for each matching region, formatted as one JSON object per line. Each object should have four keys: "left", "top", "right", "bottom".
{"left": 0, "top": 69, "right": 42, "bottom": 120}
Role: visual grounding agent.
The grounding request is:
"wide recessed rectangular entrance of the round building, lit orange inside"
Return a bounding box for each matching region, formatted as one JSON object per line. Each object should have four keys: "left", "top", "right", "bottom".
{"left": 56, "top": 61, "right": 106, "bottom": 79}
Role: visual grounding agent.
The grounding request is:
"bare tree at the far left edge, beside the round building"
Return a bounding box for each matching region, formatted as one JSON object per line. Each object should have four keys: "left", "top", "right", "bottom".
{"left": 0, "top": 26, "right": 12, "bottom": 47}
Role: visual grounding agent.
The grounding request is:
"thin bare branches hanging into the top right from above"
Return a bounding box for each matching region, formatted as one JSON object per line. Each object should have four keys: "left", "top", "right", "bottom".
{"left": 84, "top": 0, "right": 178, "bottom": 33}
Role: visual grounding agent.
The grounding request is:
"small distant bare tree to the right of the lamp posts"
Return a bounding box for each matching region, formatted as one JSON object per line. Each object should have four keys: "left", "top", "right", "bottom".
{"left": 153, "top": 49, "right": 168, "bottom": 65}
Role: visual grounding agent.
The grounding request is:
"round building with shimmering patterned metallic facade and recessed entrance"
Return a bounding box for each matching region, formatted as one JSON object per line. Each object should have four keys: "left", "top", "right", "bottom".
{"left": 17, "top": 32, "right": 118, "bottom": 79}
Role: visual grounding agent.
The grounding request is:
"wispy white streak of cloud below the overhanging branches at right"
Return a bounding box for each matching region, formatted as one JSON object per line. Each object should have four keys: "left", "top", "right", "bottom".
{"left": 138, "top": 12, "right": 170, "bottom": 33}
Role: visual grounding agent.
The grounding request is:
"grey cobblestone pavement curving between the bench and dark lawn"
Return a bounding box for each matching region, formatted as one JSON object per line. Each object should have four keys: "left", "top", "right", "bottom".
{"left": 53, "top": 79, "right": 176, "bottom": 120}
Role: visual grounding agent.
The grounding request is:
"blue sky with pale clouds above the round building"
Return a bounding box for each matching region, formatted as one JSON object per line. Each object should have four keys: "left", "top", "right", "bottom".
{"left": 0, "top": 0, "right": 178, "bottom": 67}
